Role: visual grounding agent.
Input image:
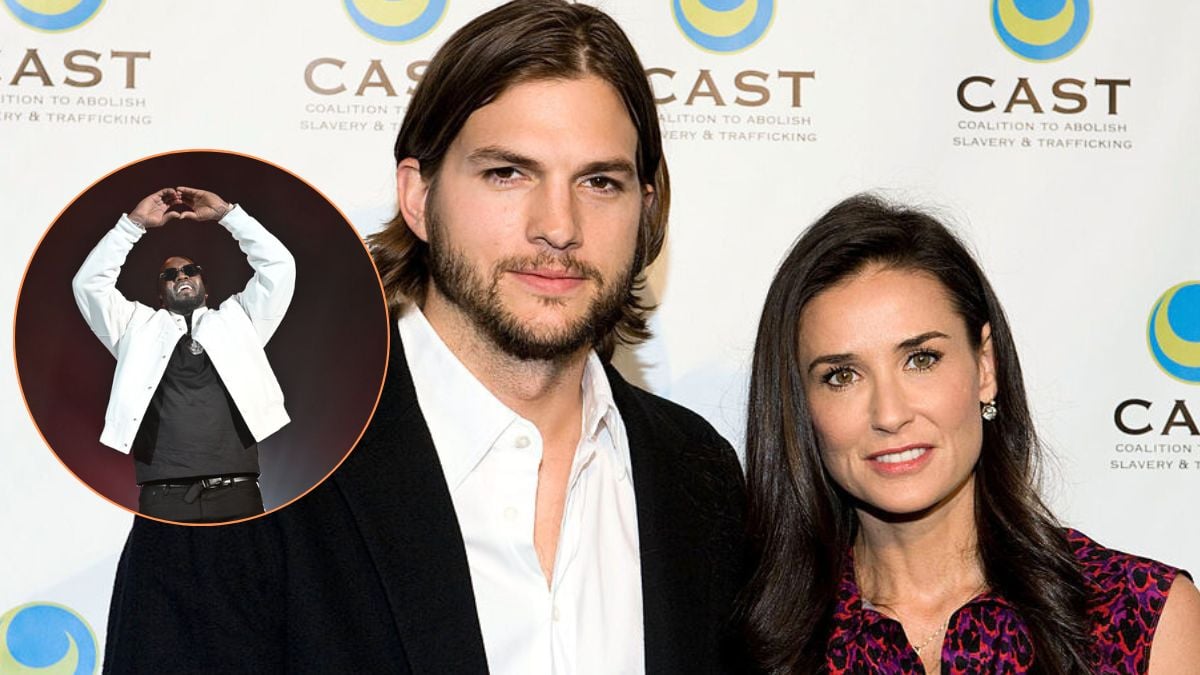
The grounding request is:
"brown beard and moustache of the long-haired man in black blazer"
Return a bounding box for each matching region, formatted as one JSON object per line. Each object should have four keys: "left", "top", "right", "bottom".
{"left": 426, "top": 201, "right": 634, "bottom": 360}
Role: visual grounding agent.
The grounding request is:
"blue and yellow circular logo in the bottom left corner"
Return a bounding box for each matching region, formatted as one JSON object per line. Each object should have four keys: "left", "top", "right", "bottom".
{"left": 0, "top": 603, "right": 96, "bottom": 675}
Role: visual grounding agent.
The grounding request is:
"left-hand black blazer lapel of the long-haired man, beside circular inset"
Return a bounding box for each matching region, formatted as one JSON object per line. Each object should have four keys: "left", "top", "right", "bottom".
{"left": 334, "top": 322, "right": 487, "bottom": 673}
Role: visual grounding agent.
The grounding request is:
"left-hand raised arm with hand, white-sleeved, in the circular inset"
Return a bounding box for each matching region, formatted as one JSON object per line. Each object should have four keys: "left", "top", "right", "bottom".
{"left": 71, "top": 187, "right": 181, "bottom": 356}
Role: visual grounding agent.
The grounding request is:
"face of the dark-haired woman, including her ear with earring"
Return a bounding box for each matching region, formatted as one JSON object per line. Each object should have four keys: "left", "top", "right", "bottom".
{"left": 799, "top": 265, "right": 1003, "bottom": 515}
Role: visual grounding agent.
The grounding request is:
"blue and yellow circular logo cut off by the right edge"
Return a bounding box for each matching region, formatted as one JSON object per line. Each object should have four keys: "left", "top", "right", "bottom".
{"left": 1146, "top": 281, "right": 1200, "bottom": 384}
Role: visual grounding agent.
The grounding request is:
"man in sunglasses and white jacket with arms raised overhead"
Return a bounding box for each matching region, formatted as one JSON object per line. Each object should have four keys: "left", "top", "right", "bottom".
{"left": 72, "top": 187, "right": 295, "bottom": 522}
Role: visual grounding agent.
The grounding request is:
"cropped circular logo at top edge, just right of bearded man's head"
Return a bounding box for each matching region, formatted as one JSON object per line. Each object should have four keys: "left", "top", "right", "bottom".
{"left": 671, "top": 0, "right": 775, "bottom": 54}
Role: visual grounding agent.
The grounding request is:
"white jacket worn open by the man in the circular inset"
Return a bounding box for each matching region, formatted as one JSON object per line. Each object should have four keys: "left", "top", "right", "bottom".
{"left": 71, "top": 207, "right": 296, "bottom": 453}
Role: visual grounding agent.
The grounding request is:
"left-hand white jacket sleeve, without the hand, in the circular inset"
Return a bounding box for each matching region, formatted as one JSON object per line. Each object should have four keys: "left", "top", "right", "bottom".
{"left": 71, "top": 215, "right": 146, "bottom": 356}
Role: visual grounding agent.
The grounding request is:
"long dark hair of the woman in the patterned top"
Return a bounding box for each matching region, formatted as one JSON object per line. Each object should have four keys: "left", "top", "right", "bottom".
{"left": 746, "top": 195, "right": 1090, "bottom": 675}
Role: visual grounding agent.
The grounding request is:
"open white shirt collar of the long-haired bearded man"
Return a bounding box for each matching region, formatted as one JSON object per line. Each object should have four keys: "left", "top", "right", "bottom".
{"left": 397, "top": 303, "right": 630, "bottom": 491}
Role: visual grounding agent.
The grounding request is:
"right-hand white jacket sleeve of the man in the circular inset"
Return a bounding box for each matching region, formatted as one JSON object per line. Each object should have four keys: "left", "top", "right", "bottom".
{"left": 221, "top": 207, "right": 296, "bottom": 345}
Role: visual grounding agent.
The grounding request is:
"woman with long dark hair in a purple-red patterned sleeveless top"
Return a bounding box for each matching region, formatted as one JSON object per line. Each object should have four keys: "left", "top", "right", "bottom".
{"left": 746, "top": 196, "right": 1200, "bottom": 675}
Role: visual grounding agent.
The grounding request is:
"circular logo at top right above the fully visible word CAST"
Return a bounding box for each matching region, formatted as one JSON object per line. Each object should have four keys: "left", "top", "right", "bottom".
{"left": 991, "top": 0, "right": 1092, "bottom": 61}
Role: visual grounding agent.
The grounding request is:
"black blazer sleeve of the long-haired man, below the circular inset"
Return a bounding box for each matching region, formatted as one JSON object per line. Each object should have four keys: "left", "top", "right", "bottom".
{"left": 103, "top": 516, "right": 288, "bottom": 674}
